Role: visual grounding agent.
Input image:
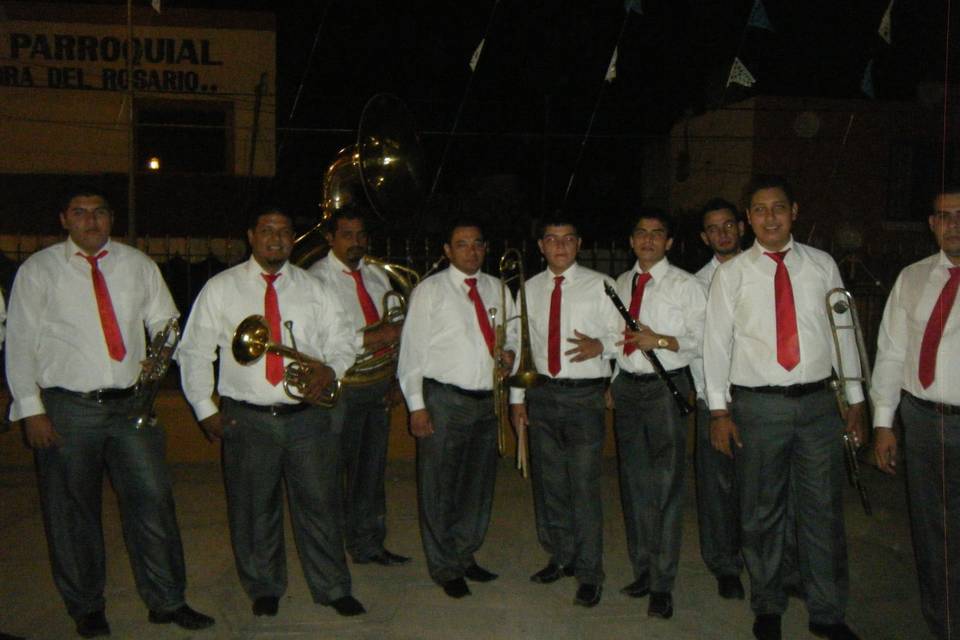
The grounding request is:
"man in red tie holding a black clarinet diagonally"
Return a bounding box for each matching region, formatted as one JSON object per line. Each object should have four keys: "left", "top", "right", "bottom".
{"left": 610, "top": 209, "right": 707, "bottom": 618}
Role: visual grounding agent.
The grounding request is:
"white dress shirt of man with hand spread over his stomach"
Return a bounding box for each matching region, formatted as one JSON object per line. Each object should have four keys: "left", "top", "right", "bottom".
{"left": 510, "top": 263, "right": 629, "bottom": 404}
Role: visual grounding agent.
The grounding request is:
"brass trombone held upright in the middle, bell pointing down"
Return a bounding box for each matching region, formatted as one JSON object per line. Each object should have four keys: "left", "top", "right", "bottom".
{"left": 490, "top": 249, "right": 546, "bottom": 478}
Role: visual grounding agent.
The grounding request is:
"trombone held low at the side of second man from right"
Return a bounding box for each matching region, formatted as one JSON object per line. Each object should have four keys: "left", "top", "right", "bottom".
{"left": 824, "top": 287, "right": 873, "bottom": 516}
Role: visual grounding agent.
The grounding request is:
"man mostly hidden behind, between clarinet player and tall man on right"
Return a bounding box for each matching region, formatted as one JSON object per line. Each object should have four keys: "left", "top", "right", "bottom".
{"left": 690, "top": 198, "right": 745, "bottom": 600}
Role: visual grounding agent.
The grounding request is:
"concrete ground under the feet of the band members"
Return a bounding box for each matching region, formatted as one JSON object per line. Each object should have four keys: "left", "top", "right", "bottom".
{"left": 0, "top": 430, "right": 928, "bottom": 640}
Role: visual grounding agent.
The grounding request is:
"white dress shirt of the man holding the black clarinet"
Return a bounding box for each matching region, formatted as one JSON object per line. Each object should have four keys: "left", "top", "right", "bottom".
{"left": 614, "top": 258, "right": 707, "bottom": 377}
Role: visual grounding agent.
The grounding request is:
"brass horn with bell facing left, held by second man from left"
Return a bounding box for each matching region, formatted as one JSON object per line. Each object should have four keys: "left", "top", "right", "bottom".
{"left": 230, "top": 315, "right": 341, "bottom": 408}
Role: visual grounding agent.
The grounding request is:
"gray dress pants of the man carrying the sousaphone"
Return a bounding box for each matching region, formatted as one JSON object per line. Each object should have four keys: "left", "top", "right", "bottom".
{"left": 333, "top": 380, "right": 393, "bottom": 560}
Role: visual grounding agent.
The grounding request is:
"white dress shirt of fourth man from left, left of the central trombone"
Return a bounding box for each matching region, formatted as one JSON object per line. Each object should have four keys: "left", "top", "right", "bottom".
{"left": 397, "top": 266, "right": 518, "bottom": 411}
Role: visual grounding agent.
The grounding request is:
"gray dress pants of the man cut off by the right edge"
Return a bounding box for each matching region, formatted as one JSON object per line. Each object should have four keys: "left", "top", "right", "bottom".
{"left": 900, "top": 393, "right": 960, "bottom": 640}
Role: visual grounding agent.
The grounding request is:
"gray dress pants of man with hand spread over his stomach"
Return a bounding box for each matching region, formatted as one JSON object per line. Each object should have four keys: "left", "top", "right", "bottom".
{"left": 526, "top": 383, "right": 606, "bottom": 585}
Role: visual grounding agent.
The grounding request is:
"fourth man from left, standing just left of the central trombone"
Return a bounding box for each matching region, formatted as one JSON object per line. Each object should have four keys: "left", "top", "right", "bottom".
{"left": 397, "top": 219, "right": 516, "bottom": 598}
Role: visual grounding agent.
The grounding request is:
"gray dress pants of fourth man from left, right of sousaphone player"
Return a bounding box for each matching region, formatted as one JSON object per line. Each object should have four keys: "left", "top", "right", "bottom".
{"left": 417, "top": 380, "right": 497, "bottom": 584}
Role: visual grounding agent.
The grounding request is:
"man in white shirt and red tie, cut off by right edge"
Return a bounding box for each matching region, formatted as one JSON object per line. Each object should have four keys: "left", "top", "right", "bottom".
{"left": 870, "top": 185, "right": 960, "bottom": 640}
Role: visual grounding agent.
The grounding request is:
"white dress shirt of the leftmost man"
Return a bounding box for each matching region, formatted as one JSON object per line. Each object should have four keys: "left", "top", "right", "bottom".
{"left": 6, "top": 238, "right": 180, "bottom": 420}
